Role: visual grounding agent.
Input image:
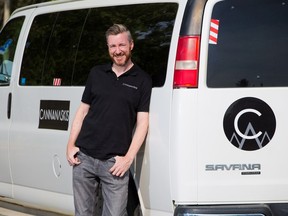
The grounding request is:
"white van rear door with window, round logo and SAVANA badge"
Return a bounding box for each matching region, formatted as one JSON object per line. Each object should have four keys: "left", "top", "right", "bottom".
{"left": 197, "top": 0, "right": 288, "bottom": 203}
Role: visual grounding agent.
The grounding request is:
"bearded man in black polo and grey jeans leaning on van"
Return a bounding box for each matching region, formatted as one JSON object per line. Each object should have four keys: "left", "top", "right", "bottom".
{"left": 67, "top": 24, "right": 152, "bottom": 216}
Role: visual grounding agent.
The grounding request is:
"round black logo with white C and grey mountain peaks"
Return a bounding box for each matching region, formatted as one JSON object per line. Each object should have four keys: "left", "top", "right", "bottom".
{"left": 223, "top": 97, "right": 276, "bottom": 151}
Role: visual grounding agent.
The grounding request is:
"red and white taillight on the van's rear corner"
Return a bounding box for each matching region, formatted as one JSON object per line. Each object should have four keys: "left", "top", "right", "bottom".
{"left": 173, "top": 36, "right": 200, "bottom": 88}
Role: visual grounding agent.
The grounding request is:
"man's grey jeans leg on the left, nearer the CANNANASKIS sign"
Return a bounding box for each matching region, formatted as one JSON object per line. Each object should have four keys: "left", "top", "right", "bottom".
{"left": 73, "top": 152, "right": 99, "bottom": 216}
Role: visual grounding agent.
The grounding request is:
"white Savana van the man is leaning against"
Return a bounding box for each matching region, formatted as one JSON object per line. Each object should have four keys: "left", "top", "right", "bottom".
{"left": 0, "top": 0, "right": 288, "bottom": 216}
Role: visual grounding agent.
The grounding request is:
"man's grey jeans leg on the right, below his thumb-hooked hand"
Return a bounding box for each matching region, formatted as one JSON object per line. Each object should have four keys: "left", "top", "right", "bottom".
{"left": 99, "top": 158, "right": 129, "bottom": 216}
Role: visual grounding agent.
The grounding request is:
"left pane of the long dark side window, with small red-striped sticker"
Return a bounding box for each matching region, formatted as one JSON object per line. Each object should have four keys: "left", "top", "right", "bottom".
{"left": 19, "top": 10, "right": 87, "bottom": 86}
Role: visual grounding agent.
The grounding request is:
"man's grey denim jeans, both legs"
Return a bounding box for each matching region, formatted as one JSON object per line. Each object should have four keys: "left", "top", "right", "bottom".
{"left": 73, "top": 152, "right": 129, "bottom": 216}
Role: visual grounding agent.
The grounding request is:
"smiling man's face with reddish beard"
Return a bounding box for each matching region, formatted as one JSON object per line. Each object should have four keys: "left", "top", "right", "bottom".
{"left": 107, "top": 32, "right": 134, "bottom": 66}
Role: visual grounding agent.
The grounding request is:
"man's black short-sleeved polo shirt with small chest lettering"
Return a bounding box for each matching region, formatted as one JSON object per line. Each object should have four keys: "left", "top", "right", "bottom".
{"left": 76, "top": 64, "right": 152, "bottom": 160}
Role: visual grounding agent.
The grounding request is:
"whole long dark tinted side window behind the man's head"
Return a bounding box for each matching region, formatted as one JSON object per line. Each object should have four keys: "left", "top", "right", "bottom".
{"left": 19, "top": 3, "right": 178, "bottom": 87}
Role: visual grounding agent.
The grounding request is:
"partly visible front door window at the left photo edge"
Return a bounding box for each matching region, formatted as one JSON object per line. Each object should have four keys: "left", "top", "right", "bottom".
{"left": 0, "top": 17, "right": 24, "bottom": 86}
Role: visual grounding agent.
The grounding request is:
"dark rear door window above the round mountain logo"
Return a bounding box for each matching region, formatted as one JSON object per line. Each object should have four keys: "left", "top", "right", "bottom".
{"left": 207, "top": 0, "right": 288, "bottom": 88}
